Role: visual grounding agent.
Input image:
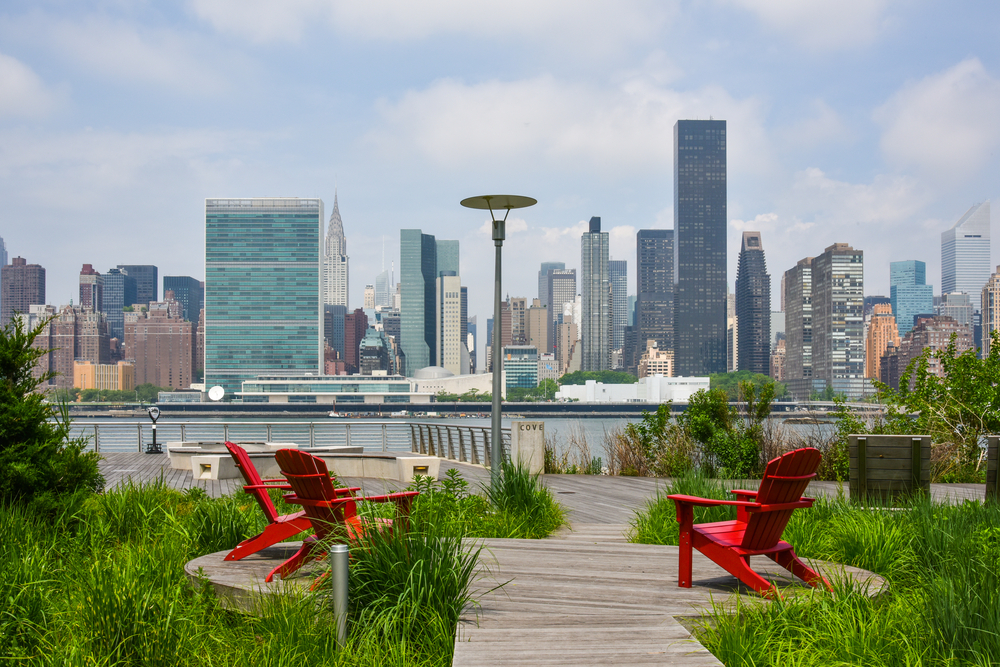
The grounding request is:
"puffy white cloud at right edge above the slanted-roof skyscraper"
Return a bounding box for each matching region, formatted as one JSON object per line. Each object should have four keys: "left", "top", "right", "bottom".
{"left": 875, "top": 58, "right": 1000, "bottom": 181}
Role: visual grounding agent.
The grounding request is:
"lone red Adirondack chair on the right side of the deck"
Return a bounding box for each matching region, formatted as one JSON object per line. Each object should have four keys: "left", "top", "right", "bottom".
{"left": 667, "top": 447, "right": 833, "bottom": 595}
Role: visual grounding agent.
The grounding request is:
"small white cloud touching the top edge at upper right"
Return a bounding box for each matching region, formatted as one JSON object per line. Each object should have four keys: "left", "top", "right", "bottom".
{"left": 727, "top": 0, "right": 889, "bottom": 51}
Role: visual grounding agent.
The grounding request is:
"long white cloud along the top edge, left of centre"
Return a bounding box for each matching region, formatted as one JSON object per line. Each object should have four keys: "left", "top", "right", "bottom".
{"left": 189, "top": 0, "right": 676, "bottom": 51}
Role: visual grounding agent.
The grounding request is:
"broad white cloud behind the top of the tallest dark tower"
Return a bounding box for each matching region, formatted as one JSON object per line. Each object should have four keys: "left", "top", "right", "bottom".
{"left": 368, "top": 76, "right": 770, "bottom": 176}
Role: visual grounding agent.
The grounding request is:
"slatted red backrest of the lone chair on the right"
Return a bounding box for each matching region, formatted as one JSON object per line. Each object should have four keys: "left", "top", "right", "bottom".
{"left": 740, "top": 447, "right": 822, "bottom": 549}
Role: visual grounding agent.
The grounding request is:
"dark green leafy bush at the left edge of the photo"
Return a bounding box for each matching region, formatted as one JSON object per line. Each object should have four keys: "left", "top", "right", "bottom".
{"left": 0, "top": 317, "right": 104, "bottom": 508}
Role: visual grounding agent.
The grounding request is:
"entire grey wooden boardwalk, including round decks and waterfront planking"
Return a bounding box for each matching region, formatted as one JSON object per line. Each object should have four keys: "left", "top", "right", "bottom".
{"left": 101, "top": 453, "right": 985, "bottom": 667}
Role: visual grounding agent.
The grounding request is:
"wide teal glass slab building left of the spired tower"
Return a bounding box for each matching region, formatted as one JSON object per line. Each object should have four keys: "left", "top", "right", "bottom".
{"left": 205, "top": 197, "right": 323, "bottom": 395}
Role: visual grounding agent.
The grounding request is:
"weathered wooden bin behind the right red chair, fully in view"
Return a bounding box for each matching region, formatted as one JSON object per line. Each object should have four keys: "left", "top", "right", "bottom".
{"left": 848, "top": 435, "right": 931, "bottom": 501}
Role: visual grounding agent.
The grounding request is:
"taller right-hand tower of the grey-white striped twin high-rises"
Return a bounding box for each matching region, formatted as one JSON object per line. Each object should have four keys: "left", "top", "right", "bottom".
{"left": 812, "top": 243, "right": 865, "bottom": 399}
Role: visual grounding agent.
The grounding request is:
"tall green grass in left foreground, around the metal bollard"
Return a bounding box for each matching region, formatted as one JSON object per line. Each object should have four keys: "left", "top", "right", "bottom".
{"left": 0, "top": 480, "right": 524, "bottom": 667}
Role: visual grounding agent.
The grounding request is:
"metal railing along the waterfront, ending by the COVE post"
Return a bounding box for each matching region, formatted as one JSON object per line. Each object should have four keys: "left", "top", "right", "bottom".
{"left": 71, "top": 419, "right": 510, "bottom": 465}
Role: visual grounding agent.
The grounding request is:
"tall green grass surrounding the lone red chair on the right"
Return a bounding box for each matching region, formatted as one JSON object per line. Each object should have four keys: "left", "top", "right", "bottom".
{"left": 633, "top": 481, "right": 1000, "bottom": 667}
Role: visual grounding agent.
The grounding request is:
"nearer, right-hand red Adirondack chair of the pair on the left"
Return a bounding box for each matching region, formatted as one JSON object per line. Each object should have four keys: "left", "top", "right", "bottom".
{"left": 265, "top": 449, "right": 419, "bottom": 582}
